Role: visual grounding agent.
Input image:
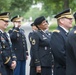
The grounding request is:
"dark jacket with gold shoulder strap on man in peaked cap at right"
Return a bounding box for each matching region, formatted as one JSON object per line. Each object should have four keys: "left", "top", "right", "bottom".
{"left": 51, "top": 26, "right": 67, "bottom": 75}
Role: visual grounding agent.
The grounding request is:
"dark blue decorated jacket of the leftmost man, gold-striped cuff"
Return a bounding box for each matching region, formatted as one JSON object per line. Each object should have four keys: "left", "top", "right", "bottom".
{"left": 0, "top": 31, "right": 16, "bottom": 75}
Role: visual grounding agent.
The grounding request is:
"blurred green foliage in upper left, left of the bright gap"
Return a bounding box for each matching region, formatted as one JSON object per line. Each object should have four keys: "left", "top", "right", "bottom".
{"left": 0, "top": 0, "right": 33, "bottom": 16}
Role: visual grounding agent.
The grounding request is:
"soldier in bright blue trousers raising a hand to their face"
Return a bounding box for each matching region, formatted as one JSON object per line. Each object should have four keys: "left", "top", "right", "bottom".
{"left": 9, "top": 15, "right": 28, "bottom": 75}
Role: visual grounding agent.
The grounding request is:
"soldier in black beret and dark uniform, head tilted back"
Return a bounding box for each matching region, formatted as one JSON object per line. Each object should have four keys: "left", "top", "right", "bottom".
{"left": 30, "top": 16, "right": 52, "bottom": 75}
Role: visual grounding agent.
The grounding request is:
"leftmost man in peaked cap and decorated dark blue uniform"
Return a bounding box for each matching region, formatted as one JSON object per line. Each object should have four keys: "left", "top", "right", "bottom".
{"left": 0, "top": 12, "right": 16, "bottom": 75}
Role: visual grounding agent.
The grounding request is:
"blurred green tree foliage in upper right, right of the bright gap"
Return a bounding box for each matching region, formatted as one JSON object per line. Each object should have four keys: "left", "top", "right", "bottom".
{"left": 35, "top": 0, "right": 76, "bottom": 15}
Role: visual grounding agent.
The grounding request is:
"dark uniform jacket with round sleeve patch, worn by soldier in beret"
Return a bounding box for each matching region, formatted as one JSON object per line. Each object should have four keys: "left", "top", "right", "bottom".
{"left": 30, "top": 30, "right": 52, "bottom": 67}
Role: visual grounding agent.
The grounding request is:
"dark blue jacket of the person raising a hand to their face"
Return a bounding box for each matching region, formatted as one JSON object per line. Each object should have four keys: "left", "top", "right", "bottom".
{"left": 9, "top": 27, "right": 28, "bottom": 60}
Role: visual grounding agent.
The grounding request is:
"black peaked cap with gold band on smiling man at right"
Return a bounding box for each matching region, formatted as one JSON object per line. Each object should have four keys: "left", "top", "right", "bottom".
{"left": 54, "top": 8, "right": 73, "bottom": 19}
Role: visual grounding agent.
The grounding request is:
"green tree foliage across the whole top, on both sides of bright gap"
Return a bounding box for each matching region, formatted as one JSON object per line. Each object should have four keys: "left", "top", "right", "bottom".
{"left": 0, "top": 0, "right": 76, "bottom": 16}
